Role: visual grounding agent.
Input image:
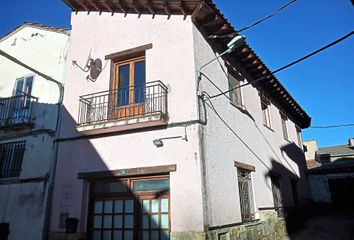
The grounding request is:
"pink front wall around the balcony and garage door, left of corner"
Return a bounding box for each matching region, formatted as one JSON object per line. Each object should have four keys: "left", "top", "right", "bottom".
{"left": 51, "top": 12, "right": 204, "bottom": 235}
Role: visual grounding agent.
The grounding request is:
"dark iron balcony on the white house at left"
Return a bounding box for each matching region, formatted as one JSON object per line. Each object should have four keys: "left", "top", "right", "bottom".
{"left": 0, "top": 94, "right": 38, "bottom": 129}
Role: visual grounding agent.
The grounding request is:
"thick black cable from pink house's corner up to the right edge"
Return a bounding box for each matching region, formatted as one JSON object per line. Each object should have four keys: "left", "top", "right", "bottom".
{"left": 210, "top": 31, "right": 354, "bottom": 99}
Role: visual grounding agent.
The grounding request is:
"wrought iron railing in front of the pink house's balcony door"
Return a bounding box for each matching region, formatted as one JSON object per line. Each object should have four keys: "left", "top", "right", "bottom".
{"left": 78, "top": 81, "right": 167, "bottom": 125}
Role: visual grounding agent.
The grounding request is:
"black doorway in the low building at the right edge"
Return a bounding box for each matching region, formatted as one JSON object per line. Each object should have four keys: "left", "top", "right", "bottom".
{"left": 328, "top": 177, "right": 354, "bottom": 210}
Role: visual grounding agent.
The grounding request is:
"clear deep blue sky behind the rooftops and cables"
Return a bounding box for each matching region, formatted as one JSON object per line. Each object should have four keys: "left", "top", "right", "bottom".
{"left": 0, "top": 0, "right": 354, "bottom": 146}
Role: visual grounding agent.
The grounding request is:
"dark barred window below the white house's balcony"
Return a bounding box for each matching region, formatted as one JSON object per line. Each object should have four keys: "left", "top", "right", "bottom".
{"left": 0, "top": 141, "right": 26, "bottom": 178}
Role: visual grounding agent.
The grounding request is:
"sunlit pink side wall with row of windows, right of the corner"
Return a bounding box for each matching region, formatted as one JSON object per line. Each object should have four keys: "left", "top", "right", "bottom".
{"left": 193, "top": 25, "right": 307, "bottom": 226}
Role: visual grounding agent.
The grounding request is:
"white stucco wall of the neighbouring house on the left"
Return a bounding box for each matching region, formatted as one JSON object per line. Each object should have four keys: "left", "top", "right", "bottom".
{"left": 0, "top": 26, "right": 69, "bottom": 240}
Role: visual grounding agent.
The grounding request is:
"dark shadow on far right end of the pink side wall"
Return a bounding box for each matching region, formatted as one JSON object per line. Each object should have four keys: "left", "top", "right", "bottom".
{"left": 265, "top": 143, "right": 309, "bottom": 239}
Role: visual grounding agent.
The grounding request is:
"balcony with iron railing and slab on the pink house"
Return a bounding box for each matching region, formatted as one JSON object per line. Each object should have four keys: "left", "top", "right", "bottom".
{"left": 77, "top": 81, "right": 167, "bottom": 134}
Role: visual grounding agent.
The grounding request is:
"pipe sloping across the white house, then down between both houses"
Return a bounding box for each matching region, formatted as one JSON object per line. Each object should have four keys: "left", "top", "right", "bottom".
{"left": 0, "top": 50, "right": 64, "bottom": 240}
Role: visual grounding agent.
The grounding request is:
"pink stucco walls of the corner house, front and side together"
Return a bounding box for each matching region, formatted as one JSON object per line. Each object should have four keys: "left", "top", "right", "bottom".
{"left": 50, "top": 6, "right": 307, "bottom": 239}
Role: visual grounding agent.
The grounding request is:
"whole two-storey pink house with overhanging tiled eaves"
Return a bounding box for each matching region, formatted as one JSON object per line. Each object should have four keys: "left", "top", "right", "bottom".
{"left": 50, "top": 0, "right": 311, "bottom": 240}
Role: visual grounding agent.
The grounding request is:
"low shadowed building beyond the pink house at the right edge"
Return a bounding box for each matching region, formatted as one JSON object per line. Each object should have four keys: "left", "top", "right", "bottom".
{"left": 304, "top": 138, "right": 354, "bottom": 208}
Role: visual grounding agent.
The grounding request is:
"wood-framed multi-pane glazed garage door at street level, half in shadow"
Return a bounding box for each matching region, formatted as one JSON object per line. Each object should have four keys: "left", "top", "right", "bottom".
{"left": 90, "top": 176, "right": 170, "bottom": 240}
